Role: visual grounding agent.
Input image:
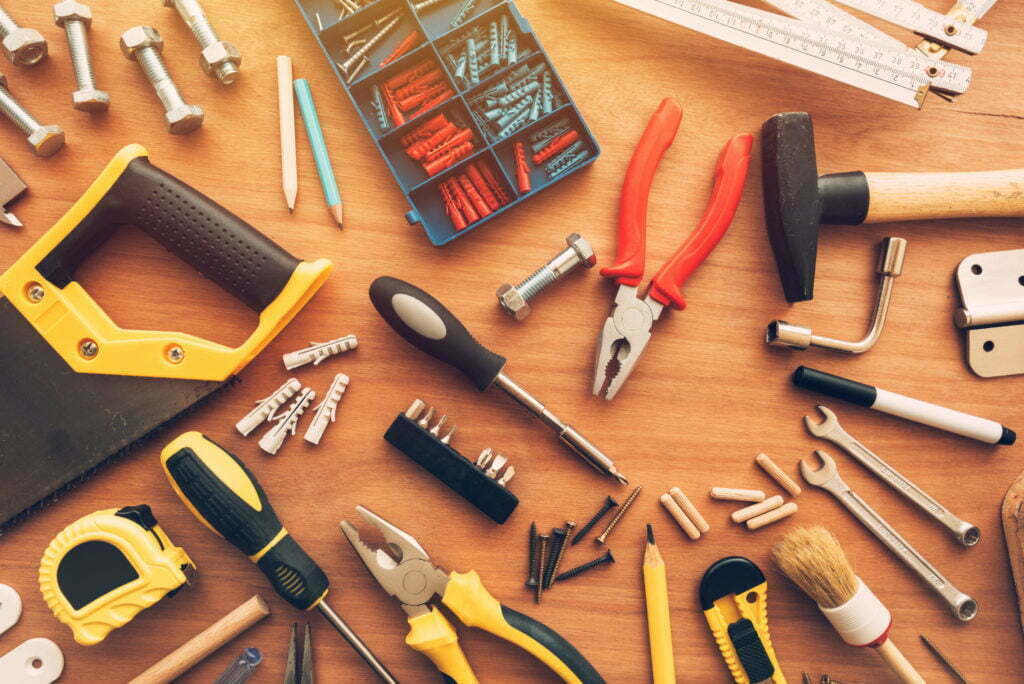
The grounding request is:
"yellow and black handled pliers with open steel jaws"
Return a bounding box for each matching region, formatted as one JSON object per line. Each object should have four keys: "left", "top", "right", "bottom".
{"left": 341, "top": 506, "right": 604, "bottom": 684}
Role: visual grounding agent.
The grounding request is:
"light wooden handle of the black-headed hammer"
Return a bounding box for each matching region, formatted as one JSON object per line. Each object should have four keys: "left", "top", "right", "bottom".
{"left": 864, "top": 169, "right": 1024, "bottom": 223}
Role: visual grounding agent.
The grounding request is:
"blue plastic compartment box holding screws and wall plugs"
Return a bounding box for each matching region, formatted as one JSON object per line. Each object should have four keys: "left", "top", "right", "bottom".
{"left": 295, "top": 0, "right": 600, "bottom": 246}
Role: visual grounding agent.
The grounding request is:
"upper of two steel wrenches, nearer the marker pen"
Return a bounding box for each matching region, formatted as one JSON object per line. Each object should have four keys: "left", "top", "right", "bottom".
{"left": 804, "top": 405, "right": 981, "bottom": 547}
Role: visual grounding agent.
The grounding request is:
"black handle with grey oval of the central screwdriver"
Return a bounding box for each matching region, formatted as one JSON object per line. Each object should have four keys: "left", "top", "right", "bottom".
{"left": 370, "top": 276, "right": 505, "bottom": 392}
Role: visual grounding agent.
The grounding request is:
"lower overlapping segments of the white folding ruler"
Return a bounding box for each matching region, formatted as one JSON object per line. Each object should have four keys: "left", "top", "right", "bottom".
{"left": 613, "top": 0, "right": 983, "bottom": 109}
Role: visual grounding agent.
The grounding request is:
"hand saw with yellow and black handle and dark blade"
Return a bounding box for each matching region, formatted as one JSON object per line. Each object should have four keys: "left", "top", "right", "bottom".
{"left": 0, "top": 145, "right": 332, "bottom": 527}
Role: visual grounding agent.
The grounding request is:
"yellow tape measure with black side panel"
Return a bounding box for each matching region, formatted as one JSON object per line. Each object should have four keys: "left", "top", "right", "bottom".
{"left": 39, "top": 505, "right": 196, "bottom": 646}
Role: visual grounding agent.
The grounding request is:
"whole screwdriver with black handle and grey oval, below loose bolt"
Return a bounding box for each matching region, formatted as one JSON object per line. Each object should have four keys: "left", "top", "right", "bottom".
{"left": 370, "top": 276, "right": 629, "bottom": 484}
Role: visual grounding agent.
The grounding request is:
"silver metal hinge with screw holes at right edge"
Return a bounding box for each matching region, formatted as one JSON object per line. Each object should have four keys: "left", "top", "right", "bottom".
{"left": 953, "top": 250, "right": 1024, "bottom": 378}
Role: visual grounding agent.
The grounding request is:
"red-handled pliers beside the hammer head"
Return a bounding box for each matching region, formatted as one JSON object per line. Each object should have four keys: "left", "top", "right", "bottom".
{"left": 594, "top": 98, "right": 754, "bottom": 399}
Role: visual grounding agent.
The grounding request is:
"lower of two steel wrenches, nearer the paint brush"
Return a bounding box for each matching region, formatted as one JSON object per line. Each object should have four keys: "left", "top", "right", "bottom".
{"left": 800, "top": 451, "right": 978, "bottom": 623}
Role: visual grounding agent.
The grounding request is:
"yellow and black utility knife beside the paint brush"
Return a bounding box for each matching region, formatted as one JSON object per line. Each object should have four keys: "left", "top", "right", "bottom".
{"left": 700, "top": 556, "right": 785, "bottom": 684}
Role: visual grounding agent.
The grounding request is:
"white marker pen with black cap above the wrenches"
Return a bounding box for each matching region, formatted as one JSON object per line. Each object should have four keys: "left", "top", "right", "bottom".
{"left": 793, "top": 366, "right": 1017, "bottom": 444}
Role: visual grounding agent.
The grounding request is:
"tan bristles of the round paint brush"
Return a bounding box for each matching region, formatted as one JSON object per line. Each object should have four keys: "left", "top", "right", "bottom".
{"left": 771, "top": 526, "right": 858, "bottom": 608}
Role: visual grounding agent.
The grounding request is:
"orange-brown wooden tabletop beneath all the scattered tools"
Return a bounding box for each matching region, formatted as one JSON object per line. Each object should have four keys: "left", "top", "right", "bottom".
{"left": 0, "top": 0, "right": 1024, "bottom": 682}
